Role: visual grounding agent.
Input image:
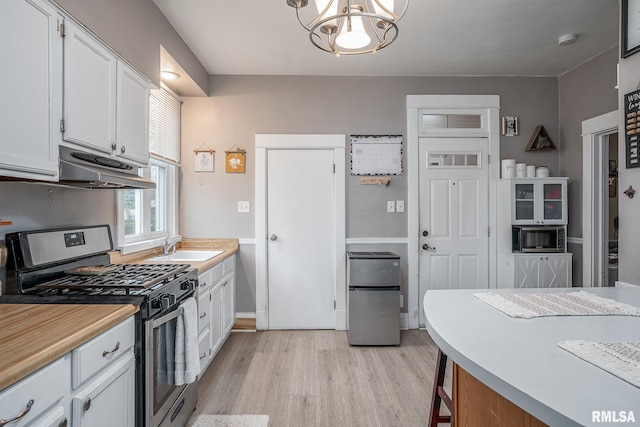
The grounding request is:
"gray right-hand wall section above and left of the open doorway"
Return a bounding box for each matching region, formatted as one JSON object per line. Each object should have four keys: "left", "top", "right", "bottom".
{"left": 558, "top": 47, "right": 618, "bottom": 286}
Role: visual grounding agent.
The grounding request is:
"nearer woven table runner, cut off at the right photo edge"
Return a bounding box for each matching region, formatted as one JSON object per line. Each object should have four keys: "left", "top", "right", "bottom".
{"left": 558, "top": 340, "right": 640, "bottom": 388}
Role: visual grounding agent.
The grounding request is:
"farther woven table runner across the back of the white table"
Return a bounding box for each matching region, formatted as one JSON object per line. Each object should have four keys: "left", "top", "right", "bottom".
{"left": 474, "top": 291, "right": 640, "bottom": 319}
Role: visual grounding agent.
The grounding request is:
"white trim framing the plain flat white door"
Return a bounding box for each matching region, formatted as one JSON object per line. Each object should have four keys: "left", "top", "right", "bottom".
{"left": 254, "top": 134, "right": 347, "bottom": 330}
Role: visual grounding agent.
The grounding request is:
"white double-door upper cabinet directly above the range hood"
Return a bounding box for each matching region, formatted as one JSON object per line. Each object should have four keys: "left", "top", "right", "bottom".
{"left": 63, "top": 20, "right": 149, "bottom": 165}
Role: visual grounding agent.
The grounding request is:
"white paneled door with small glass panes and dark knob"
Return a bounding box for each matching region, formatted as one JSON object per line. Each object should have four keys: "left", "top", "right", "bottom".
{"left": 419, "top": 138, "right": 489, "bottom": 323}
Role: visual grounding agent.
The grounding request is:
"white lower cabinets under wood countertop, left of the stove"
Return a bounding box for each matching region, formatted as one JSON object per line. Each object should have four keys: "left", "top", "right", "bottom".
{"left": 0, "top": 317, "right": 135, "bottom": 427}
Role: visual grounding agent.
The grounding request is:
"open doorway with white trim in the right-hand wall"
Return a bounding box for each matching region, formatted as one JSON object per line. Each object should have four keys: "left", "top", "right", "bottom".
{"left": 582, "top": 111, "right": 620, "bottom": 287}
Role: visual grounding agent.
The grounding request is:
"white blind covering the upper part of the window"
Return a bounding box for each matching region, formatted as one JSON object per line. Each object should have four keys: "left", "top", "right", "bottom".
{"left": 149, "top": 88, "right": 182, "bottom": 164}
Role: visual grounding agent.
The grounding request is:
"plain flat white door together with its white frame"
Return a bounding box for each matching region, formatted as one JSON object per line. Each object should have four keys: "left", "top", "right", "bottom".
{"left": 255, "top": 135, "right": 346, "bottom": 330}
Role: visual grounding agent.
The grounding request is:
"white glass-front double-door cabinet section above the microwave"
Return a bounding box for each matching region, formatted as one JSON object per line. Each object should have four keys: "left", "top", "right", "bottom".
{"left": 506, "top": 178, "right": 567, "bottom": 225}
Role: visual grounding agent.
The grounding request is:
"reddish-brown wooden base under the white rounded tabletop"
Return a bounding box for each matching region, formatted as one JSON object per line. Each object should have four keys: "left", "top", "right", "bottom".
{"left": 453, "top": 363, "right": 547, "bottom": 427}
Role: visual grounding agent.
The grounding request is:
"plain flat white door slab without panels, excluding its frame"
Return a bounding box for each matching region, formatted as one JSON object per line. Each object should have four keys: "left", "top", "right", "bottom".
{"left": 266, "top": 149, "right": 336, "bottom": 329}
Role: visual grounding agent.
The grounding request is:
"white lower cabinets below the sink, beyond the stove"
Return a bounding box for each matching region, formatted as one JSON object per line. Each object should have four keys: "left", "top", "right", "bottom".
{"left": 198, "top": 255, "right": 236, "bottom": 375}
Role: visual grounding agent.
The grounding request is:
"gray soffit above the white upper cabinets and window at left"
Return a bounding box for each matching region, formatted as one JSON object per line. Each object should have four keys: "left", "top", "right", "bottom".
{"left": 56, "top": 0, "right": 209, "bottom": 93}
